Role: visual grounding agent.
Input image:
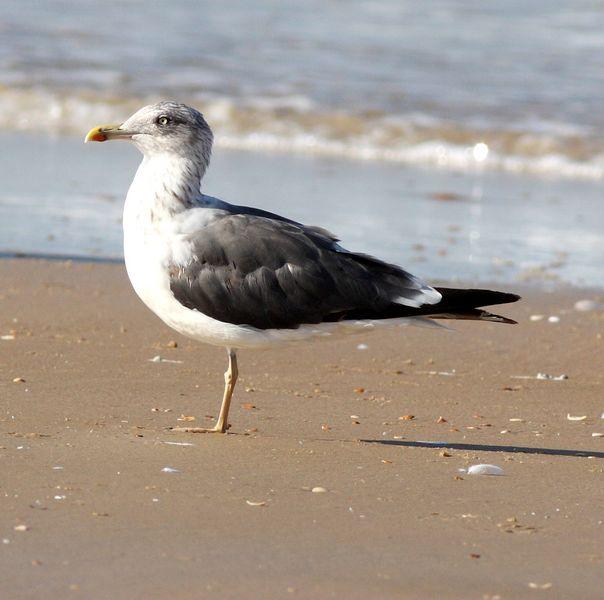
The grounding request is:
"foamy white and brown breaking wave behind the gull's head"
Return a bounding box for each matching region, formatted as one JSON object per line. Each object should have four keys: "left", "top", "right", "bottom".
{"left": 0, "top": 87, "right": 604, "bottom": 180}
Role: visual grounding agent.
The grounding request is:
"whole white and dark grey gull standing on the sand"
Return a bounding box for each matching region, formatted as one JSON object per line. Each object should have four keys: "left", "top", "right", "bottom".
{"left": 85, "top": 101, "right": 519, "bottom": 433}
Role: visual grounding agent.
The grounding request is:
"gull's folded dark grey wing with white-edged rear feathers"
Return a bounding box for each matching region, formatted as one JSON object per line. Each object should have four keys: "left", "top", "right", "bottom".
{"left": 170, "top": 210, "right": 440, "bottom": 329}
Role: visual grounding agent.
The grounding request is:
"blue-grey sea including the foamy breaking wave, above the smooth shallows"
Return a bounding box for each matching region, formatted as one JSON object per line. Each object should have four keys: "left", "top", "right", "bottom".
{"left": 0, "top": 0, "right": 604, "bottom": 180}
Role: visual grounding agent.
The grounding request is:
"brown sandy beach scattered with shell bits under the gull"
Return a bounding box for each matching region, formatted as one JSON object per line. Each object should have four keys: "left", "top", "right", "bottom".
{"left": 0, "top": 260, "right": 604, "bottom": 599}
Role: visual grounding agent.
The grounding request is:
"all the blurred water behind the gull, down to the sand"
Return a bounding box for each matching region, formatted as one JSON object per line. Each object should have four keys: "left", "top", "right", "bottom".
{"left": 0, "top": 0, "right": 604, "bottom": 285}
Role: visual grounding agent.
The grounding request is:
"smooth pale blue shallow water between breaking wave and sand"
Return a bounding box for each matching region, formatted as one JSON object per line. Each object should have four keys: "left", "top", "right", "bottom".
{"left": 0, "top": 133, "right": 604, "bottom": 288}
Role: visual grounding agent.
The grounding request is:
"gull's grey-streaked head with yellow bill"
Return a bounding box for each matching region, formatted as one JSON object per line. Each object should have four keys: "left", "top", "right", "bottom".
{"left": 84, "top": 101, "right": 213, "bottom": 165}
